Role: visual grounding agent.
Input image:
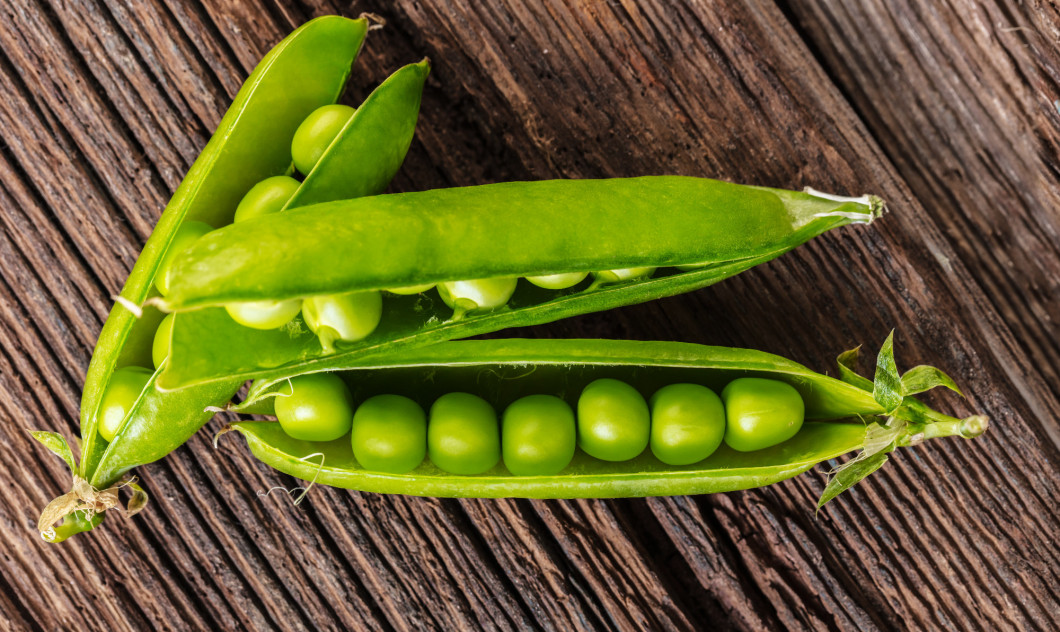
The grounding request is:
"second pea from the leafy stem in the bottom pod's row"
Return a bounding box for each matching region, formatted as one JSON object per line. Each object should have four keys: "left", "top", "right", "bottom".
{"left": 651, "top": 384, "right": 725, "bottom": 466}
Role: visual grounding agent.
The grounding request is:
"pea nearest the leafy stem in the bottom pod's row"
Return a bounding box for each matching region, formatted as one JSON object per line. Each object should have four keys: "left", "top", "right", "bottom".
{"left": 722, "top": 378, "right": 806, "bottom": 452}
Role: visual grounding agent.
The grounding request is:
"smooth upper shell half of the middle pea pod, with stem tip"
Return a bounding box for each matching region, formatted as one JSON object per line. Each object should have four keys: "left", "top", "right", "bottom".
{"left": 161, "top": 176, "right": 876, "bottom": 311}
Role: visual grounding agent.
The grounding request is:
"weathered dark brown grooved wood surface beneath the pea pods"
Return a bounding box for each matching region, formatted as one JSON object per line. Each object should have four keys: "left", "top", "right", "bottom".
{"left": 0, "top": 0, "right": 1060, "bottom": 630}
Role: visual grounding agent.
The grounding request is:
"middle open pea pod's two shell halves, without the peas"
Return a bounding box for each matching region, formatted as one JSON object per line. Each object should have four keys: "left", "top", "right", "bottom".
{"left": 158, "top": 176, "right": 882, "bottom": 389}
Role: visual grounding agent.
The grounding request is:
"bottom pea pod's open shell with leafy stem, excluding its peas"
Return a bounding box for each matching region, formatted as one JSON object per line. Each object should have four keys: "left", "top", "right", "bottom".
{"left": 221, "top": 339, "right": 987, "bottom": 504}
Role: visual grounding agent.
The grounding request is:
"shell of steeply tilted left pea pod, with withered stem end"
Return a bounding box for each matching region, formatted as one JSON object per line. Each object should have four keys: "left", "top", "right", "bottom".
{"left": 34, "top": 17, "right": 429, "bottom": 542}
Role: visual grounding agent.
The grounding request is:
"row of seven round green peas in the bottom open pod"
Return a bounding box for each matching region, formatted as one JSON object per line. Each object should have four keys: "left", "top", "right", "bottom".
{"left": 276, "top": 373, "right": 805, "bottom": 476}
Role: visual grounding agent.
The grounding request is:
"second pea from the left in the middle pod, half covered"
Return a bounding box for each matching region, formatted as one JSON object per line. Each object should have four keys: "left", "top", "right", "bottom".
{"left": 302, "top": 292, "right": 383, "bottom": 353}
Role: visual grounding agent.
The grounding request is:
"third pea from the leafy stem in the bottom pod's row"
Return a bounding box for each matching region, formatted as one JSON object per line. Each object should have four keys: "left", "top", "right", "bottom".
{"left": 578, "top": 378, "right": 651, "bottom": 461}
